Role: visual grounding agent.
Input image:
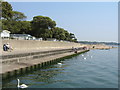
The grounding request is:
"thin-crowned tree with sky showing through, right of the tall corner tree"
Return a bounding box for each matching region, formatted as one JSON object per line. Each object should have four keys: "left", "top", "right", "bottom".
{"left": 12, "top": 11, "right": 26, "bottom": 21}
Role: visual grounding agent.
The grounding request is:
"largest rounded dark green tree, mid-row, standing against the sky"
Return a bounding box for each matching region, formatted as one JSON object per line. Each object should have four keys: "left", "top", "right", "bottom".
{"left": 31, "top": 16, "right": 56, "bottom": 39}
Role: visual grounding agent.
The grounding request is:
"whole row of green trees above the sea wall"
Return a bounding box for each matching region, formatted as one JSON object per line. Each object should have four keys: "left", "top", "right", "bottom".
{"left": 0, "top": 2, "right": 77, "bottom": 42}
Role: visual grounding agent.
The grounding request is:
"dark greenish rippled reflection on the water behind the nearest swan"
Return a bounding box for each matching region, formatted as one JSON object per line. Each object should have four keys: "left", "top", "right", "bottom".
{"left": 3, "top": 61, "right": 68, "bottom": 88}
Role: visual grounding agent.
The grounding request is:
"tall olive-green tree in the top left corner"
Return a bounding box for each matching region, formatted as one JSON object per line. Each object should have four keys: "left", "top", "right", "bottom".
{"left": 1, "top": 2, "right": 12, "bottom": 20}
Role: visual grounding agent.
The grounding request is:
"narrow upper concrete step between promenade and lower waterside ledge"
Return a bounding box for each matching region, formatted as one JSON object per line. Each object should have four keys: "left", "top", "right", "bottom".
{"left": 0, "top": 49, "right": 73, "bottom": 64}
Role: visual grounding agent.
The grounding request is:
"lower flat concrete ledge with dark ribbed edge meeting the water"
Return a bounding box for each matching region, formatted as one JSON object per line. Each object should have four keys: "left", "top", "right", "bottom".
{"left": 1, "top": 50, "right": 89, "bottom": 80}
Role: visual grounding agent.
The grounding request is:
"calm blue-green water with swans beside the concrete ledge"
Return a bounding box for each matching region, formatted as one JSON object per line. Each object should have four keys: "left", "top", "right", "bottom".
{"left": 3, "top": 49, "right": 118, "bottom": 88}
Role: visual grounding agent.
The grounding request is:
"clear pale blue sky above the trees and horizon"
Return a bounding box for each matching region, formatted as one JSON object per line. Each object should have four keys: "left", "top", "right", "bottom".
{"left": 10, "top": 2, "right": 118, "bottom": 41}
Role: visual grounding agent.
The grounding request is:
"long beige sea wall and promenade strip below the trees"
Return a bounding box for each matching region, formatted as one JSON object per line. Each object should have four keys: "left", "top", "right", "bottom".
{"left": 0, "top": 40, "right": 81, "bottom": 51}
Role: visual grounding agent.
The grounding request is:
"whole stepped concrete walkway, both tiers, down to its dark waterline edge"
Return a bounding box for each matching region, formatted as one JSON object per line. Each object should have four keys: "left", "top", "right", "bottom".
{"left": 0, "top": 48, "right": 89, "bottom": 79}
